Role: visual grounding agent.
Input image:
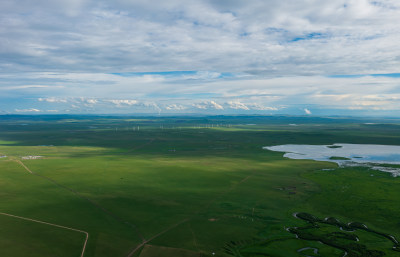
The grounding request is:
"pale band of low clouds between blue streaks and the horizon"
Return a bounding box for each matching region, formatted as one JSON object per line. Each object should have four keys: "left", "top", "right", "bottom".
{"left": 0, "top": 73, "right": 400, "bottom": 114}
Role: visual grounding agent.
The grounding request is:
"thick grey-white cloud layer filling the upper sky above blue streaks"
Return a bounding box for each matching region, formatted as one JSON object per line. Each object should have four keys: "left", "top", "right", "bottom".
{"left": 0, "top": 0, "right": 400, "bottom": 74}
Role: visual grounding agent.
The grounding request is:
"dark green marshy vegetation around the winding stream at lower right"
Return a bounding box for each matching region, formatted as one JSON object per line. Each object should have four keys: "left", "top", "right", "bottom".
{"left": 234, "top": 212, "right": 400, "bottom": 257}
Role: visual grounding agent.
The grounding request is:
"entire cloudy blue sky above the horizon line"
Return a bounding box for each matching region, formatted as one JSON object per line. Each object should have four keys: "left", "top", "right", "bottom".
{"left": 0, "top": 0, "right": 400, "bottom": 114}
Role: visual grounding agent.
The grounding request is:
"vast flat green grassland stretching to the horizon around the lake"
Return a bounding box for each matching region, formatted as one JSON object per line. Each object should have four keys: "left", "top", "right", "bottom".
{"left": 0, "top": 116, "right": 400, "bottom": 257}
